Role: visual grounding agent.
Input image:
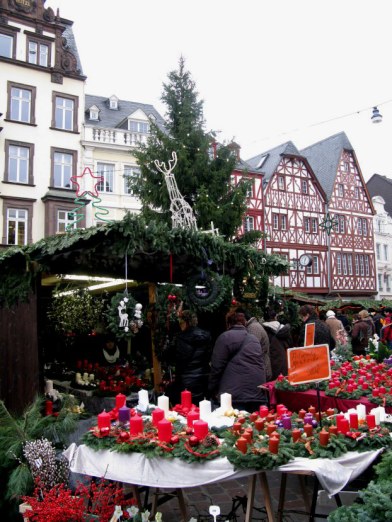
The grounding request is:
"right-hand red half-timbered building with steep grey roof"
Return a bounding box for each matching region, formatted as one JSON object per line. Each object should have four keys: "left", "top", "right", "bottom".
{"left": 301, "top": 132, "right": 377, "bottom": 296}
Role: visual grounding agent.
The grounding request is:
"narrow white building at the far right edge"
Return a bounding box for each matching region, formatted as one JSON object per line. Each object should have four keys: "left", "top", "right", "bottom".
{"left": 372, "top": 196, "right": 392, "bottom": 299}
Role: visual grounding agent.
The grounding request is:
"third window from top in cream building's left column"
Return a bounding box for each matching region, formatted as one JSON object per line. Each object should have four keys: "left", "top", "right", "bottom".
{"left": 4, "top": 140, "right": 34, "bottom": 185}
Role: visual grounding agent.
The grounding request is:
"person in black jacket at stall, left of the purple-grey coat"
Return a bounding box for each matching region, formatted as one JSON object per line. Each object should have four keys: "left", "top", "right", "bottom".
{"left": 169, "top": 310, "right": 212, "bottom": 406}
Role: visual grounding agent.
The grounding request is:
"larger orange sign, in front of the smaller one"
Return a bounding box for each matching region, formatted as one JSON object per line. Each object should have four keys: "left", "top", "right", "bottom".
{"left": 287, "top": 344, "right": 331, "bottom": 384}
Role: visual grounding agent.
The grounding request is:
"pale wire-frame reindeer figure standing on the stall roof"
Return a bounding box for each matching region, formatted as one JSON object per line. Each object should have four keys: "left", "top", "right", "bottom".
{"left": 154, "top": 151, "right": 197, "bottom": 230}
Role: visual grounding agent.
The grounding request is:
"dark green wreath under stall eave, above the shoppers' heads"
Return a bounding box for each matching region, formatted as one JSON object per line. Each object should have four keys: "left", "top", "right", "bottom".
{"left": 185, "top": 271, "right": 231, "bottom": 312}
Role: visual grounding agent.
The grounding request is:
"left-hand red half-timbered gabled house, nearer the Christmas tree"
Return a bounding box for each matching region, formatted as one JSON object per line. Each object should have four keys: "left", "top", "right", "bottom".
{"left": 247, "top": 141, "right": 329, "bottom": 295}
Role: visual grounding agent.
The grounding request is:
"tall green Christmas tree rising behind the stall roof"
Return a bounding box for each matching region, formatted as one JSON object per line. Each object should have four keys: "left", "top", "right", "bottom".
{"left": 130, "top": 58, "right": 250, "bottom": 239}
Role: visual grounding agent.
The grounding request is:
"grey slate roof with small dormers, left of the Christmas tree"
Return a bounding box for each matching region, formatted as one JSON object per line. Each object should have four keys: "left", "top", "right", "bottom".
{"left": 85, "top": 94, "right": 165, "bottom": 128}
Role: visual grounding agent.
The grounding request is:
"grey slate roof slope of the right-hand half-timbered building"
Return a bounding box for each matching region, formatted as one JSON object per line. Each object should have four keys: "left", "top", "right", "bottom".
{"left": 301, "top": 132, "right": 354, "bottom": 201}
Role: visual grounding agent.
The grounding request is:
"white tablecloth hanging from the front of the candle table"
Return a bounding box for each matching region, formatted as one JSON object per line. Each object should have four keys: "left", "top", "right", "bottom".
{"left": 64, "top": 443, "right": 382, "bottom": 495}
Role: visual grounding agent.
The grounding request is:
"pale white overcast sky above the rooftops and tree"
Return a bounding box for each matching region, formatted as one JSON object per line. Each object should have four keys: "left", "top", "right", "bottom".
{"left": 50, "top": 0, "right": 392, "bottom": 181}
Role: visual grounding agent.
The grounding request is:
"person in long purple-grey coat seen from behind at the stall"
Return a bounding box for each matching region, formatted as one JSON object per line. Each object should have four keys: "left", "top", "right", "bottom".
{"left": 209, "top": 312, "right": 266, "bottom": 412}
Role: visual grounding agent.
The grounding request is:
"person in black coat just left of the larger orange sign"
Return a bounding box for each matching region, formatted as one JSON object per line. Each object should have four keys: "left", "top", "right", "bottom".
{"left": 262, "top": 320, "right": 292, "bottom": 380}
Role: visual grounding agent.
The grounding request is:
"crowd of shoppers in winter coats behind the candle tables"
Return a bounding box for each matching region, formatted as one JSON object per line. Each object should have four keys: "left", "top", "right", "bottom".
{"left": 169, "top": 304, "right": 392, "bottom": 411}
